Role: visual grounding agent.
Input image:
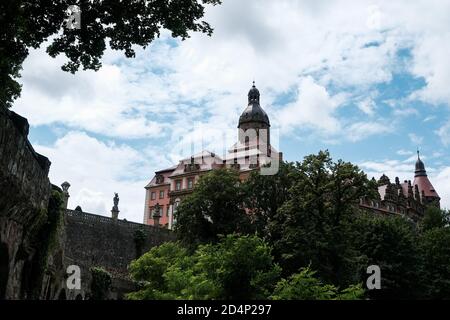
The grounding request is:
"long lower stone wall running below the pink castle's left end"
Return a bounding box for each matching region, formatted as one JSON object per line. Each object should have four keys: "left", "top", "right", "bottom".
{"left": 65, "top": 210, "right": 175, "bottom": 299}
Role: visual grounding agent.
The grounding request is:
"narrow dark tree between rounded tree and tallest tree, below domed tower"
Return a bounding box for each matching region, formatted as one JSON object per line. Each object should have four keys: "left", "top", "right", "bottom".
{"left": 243, "top": 162, "right": 296, "bottom": 241}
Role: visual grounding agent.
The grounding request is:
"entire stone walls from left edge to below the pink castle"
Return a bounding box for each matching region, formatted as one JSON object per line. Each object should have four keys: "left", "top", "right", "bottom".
{"left": 0, "top": 106, "right": 174, "bottom": 300}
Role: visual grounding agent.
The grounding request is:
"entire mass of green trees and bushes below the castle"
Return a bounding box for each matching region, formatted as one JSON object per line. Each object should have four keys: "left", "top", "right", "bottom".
{"left": 130, "top": 151, "right": 450, "bottom": 300}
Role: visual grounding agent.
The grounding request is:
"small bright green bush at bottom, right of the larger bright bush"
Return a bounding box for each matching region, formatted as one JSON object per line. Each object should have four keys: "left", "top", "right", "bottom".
{"left": 271, "top": 268, "right": 364, "bottom": 300}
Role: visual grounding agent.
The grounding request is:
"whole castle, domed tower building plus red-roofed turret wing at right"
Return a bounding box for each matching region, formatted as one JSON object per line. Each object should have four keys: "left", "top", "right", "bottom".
{"left": 143, "top": 82, "right": 440, "bottom": 229}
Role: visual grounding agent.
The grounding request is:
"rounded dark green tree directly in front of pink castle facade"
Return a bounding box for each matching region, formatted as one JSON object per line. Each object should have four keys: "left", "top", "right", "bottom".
{"left": 175, "top": 169, "right": 251, "bottom": 247}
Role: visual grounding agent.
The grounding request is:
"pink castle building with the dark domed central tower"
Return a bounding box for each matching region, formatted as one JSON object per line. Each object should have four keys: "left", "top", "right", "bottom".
{"left": 144, "top": 82, "right": 283, "bottom": 229}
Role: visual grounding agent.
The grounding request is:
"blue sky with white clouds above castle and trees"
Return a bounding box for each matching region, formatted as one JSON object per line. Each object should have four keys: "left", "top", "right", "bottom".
{"left": 12, "top": 0, "right": 450, "bottom": 222}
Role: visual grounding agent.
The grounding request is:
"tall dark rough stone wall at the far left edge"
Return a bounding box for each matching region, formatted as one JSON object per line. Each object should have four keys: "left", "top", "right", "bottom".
{"left": 0, "top": 106, "right": 51, "bottom": 299}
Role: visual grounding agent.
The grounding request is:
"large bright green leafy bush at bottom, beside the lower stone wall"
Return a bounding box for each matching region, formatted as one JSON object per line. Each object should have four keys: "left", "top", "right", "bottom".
{"left": 128, "top": 235, "right": 280, "bottom": 299}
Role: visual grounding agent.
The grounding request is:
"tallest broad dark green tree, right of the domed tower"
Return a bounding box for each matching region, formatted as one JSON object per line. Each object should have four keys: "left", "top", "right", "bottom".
{"left": 271, "top": 151, "right": 375, "bottom": 285}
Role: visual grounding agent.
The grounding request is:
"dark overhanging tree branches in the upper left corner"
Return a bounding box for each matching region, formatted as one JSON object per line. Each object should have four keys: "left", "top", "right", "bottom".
{"left": 0, "top": 0, "right": 220, "bottom": 107}
